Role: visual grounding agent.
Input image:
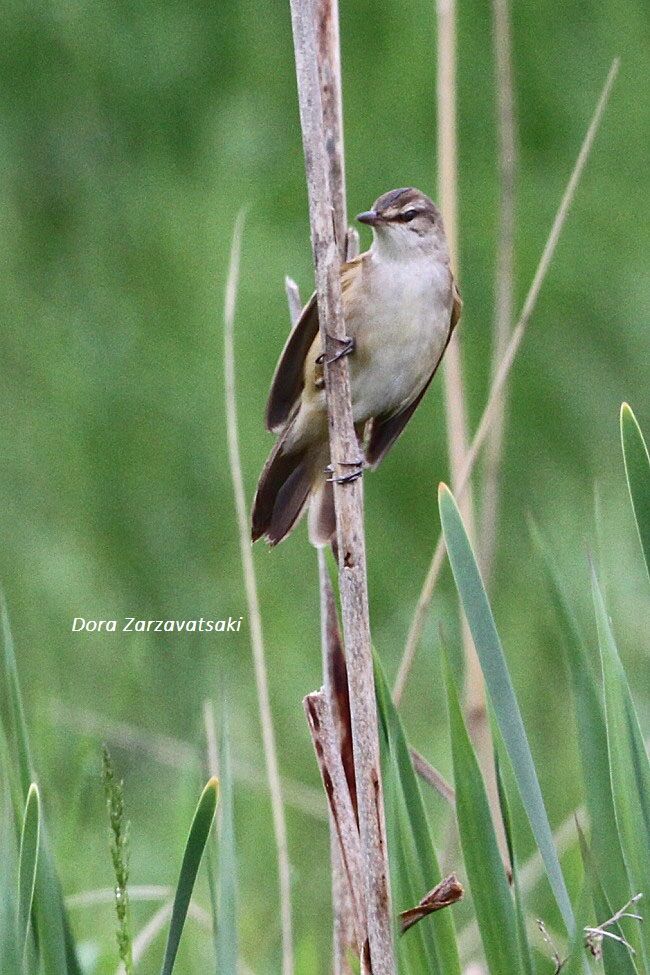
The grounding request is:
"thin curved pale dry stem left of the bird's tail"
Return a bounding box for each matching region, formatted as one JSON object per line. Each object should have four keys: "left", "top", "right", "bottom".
{"left": 224, "top": 213, "right": 293, "bottom": 975}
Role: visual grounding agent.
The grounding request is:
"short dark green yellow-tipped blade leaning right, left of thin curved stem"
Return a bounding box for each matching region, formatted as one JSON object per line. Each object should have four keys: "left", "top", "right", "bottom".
{"left": 161, "top": 778, "right": 219, "bottom": 975}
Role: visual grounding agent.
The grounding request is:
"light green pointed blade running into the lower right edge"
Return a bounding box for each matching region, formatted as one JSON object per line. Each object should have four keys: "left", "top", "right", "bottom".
{"left": 592, "top": 572, "right": 650, "bottom": 968}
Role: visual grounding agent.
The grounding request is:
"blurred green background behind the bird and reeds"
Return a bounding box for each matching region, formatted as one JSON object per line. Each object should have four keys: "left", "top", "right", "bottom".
{"left": 0, "top": 0, "right": 650, "bottom": 975}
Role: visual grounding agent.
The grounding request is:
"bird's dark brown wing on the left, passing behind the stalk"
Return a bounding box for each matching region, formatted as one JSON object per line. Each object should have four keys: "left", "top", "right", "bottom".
{"left": 266, "top": 255, "right": 363, "bottom": 433}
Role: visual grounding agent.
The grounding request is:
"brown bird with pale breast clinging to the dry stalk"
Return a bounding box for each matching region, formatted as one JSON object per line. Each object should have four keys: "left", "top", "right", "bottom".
{"left": 252, "top": 187, "right": 461, "bottom": 545}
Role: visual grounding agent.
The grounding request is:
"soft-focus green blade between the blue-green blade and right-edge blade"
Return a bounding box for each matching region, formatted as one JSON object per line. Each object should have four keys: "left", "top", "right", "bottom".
{"left": 531, "top": 526, "right": 634, "bottom": 916}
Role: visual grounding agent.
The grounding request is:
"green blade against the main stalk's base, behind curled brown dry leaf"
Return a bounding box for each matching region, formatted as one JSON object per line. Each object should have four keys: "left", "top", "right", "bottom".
{"left": 374, "top": 655, "right": 460, "bottom": 975}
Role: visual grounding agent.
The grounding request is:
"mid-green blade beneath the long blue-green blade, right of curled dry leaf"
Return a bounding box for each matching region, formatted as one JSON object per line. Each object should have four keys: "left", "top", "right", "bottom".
{"left": 445, "top": 657, "right": 523, "bottom": 975}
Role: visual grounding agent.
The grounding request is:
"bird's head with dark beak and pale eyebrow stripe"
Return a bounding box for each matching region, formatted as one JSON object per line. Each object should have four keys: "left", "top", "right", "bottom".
{"left": 357, "top": 186, "right": 449, "bottom": 261}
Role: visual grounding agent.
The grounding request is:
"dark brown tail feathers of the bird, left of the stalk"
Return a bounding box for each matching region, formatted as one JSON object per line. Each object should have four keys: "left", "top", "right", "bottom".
{"left": 252, "top": 429, "right": 331, "bottom": 545}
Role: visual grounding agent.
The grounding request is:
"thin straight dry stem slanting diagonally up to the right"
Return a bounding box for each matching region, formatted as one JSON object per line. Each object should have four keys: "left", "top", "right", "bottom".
{"left": 393, "top": 58, "right": 619, "bottom": 703}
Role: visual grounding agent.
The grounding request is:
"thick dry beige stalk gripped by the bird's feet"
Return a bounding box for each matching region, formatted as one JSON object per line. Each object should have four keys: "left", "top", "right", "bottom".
{"left": 291, "top": 0, "right": 395, "bottom": 975}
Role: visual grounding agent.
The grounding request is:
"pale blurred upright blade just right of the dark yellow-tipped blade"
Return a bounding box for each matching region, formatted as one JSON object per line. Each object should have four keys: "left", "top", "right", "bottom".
{"left": 217, "top": 712, "right": 237, "bottom": 975}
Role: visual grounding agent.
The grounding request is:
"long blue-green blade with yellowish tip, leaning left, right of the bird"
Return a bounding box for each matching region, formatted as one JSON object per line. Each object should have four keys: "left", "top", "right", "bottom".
{"left": 438, "top": 485, "right": 575, "bottom": 933}
